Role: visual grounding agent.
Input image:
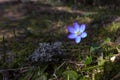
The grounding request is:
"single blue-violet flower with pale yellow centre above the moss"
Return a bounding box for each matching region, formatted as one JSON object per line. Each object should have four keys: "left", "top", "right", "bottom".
{"left": 68, "top": 22, "right": 87, "bottom": 43}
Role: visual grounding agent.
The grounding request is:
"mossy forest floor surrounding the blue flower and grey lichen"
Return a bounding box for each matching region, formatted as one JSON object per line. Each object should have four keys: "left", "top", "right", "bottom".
{"left": 0, "top": 0, "right": 120, "bottom": 80}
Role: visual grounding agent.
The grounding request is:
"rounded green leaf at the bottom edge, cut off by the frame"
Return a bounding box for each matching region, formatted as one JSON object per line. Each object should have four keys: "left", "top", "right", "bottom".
{"left": 63, "top": 70, "right": 78, "bottom": 80}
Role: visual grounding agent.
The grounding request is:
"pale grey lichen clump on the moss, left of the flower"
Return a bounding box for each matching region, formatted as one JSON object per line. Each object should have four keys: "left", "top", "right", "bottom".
{"left": 30, "top": 42, "right": 63, "bottom": 62}
